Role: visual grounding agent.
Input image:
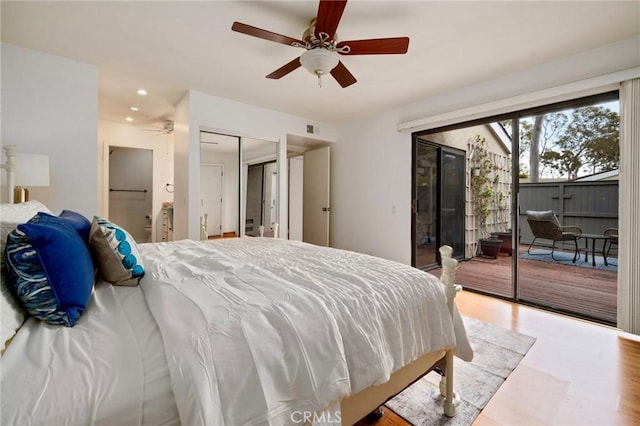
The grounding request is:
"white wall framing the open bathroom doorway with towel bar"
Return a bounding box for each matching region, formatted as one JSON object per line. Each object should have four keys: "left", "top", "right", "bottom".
{"left": 94, "top": 120, "right": 174, "bottom": 241}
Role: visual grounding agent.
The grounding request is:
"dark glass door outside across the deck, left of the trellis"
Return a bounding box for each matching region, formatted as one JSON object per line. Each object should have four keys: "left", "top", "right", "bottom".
{"left": 412, "top": 138, "right": 465, "bottom": 269}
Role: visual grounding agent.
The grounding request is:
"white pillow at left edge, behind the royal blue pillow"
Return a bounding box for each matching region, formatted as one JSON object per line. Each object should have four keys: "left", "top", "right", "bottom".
{"left": 0, "top": 200, "right": 52, "bottom": 352}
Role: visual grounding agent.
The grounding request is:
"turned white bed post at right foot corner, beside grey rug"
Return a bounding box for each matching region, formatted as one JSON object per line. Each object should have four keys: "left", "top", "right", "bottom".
{"left": 440, "top": 246, "right": 462, "bottom": 417}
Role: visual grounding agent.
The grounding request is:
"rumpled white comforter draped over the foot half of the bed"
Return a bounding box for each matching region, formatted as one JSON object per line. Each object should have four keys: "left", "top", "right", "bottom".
{"left": 141, "top": 238, "right": 466, "bottom": 425}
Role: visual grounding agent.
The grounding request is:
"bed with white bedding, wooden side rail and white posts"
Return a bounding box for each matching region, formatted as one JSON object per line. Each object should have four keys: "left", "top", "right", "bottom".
{"left": 0, "top": 198, "right": 472, "bottom": 425}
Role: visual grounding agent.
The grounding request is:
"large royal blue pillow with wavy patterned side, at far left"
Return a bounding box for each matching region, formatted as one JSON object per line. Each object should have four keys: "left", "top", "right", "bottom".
{"left": 5, "top": 213, "right": 93, "bottom": 327}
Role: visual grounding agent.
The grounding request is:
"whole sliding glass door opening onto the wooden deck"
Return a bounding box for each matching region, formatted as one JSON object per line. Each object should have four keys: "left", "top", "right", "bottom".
{"left": 412, "top": 92, "right": 620, "bottom": 324}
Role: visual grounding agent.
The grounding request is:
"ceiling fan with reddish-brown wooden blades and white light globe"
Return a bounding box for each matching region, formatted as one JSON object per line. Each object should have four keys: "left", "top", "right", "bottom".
{"left": 231, "top": 0, "right": 409, "bottom": 87}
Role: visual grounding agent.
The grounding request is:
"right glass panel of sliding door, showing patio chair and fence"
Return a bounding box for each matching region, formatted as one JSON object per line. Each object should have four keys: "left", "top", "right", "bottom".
{"left": 518, "top": 99, "right": 620, "bottom": 324}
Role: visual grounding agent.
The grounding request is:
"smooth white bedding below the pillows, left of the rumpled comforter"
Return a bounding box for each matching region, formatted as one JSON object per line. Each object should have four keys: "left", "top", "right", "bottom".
{"left": 0, "top": 282, "right": 180, "bottom": 426}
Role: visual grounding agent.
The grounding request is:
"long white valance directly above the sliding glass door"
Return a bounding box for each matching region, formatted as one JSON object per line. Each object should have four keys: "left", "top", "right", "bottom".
{"left": 397, "top": 67, "right": 640, "bottom": 132}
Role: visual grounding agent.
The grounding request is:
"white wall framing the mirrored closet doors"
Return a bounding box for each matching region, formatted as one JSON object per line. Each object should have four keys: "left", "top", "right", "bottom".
{"left": 174, "top": 91, "right": 337, "bottom": 240}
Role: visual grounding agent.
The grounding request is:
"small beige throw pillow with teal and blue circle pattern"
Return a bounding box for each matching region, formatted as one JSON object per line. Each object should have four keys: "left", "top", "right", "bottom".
{"left": 89, "top": 216, "right": 144, "bottom": 286}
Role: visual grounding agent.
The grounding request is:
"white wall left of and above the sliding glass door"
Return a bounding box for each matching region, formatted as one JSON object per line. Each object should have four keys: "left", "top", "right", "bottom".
{"left": 331, "top": 37, "right": 640, "bottom": 264}
